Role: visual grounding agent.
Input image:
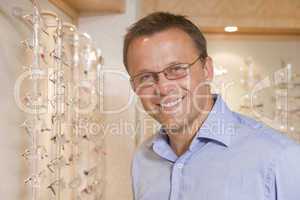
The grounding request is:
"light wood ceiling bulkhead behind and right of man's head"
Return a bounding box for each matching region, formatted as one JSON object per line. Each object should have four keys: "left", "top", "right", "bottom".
{"left": 139, "top": 0, "right": 300, "bottom": 35}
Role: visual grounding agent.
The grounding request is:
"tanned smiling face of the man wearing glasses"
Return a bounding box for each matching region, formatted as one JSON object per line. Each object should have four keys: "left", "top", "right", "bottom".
{"left": 127, "top": 28, "right": 212, "bottom": 131}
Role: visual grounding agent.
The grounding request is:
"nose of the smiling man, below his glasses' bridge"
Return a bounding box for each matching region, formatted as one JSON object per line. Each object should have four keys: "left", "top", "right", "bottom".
{"left": 155, "top": 73, "right": 177, "bottom": 96}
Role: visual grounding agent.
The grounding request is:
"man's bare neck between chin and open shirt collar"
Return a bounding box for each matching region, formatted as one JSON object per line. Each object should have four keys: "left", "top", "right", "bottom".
{"left": 167, "top": 96, "right": 214, "bottom": 156}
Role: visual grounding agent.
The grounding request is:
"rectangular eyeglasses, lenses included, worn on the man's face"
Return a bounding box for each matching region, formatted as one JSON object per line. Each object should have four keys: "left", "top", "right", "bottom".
{"left": 130, "top": 55, "right": 203, "bottom": 89}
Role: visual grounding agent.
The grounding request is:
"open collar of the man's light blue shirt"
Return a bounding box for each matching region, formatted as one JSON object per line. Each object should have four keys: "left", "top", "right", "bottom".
{"left": 150, "top": 94, "right": 238, "bottom": 158}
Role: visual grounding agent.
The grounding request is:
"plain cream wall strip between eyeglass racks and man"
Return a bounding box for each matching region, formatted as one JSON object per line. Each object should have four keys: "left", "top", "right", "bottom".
{"left": 79, "top": 0, "right": 137, "bottom": 200}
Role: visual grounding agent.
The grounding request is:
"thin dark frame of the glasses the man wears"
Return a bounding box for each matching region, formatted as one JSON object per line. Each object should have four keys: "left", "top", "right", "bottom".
{"left": 130, "top": 54, "right": 207, "bottom": 90}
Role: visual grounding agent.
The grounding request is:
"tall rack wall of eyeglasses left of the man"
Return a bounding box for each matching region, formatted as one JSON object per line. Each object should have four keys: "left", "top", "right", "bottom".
{"left": 14, "top": 1, "right": 105, "bottom": 200}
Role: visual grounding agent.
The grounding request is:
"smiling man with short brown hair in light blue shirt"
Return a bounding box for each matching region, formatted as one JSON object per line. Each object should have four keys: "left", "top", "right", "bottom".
{"left": 123, "top": 12, "right": 300, "bottom": 200}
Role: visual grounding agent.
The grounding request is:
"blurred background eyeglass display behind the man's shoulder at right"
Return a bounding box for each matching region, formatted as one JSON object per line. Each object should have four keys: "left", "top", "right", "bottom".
{"left": 215, "top": 56, "right": 300, "bottom": 142}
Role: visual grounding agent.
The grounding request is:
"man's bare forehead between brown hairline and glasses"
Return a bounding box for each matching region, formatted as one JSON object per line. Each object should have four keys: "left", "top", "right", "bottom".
{"left": 127, "top": 28, "right": 198, "bottom": 72}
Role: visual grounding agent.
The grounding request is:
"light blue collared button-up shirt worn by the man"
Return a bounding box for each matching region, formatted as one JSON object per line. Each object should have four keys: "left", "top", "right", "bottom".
{"left": 132, "top": 95, "right": 300, "bottom": 200}
